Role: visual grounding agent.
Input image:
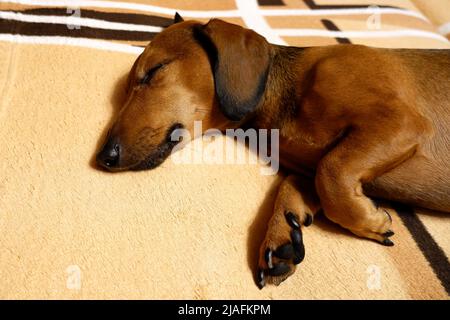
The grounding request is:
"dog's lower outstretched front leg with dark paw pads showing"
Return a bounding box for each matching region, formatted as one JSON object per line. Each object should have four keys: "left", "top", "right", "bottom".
{"left": 257, "top": 175, "right": 320, "bottom": 288}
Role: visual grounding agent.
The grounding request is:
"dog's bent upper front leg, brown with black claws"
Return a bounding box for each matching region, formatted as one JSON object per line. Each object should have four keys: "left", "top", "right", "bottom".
{"left": 315, "top": 121, "right": 420, "bottom": 246}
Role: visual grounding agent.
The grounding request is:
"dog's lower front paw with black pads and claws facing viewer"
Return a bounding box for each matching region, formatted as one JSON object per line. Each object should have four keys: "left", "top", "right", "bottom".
{"left": 257, "top": 212, "right": 312, "bottom": 289}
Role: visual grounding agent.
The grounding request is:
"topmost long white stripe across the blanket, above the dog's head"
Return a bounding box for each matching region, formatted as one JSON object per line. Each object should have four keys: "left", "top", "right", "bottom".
{"left": 0, "top": 0, "right": 429, "bottom": 21}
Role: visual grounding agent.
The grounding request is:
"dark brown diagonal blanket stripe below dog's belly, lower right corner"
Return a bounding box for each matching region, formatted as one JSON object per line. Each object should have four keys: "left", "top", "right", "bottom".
{"left": 393, "top": 203, "right": 450, "bottom": 295}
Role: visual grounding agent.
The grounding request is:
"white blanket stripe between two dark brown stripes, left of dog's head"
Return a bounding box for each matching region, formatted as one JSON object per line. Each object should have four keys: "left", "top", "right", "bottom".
{"left": 0, "top": 11, "right": 163, "bottom": 32}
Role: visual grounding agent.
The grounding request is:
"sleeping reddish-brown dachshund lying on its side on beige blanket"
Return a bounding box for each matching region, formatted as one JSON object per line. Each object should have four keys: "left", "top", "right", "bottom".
{"left": 97, "top": 16, "right": 450, "bottom": 287}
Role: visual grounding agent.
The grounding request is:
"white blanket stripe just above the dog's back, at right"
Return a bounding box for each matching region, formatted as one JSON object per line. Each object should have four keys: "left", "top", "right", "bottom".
{"left": 274, "top": 29, "right": 449, "bottom": 43}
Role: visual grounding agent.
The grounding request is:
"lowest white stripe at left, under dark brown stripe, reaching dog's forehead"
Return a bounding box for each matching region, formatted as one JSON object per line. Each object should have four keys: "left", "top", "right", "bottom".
{"left": 0, "top": 34, "right": 144, "bottom": 55}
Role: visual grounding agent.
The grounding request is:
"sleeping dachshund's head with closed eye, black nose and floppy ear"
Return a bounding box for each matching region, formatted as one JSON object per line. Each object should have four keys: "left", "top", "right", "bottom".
{"left": 97, "top": 15, "right": 270, "bottom": 171}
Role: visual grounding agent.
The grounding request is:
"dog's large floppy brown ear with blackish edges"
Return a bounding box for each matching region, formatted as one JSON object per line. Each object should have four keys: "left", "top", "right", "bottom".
{"left": 194, "top": 19, "right": 270, "bottom": 121}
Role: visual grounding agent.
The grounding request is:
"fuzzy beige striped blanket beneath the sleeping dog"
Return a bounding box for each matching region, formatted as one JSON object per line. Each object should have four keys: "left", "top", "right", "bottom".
{"left": 0, "top": 0, "right": 450, "bottom": 299}
